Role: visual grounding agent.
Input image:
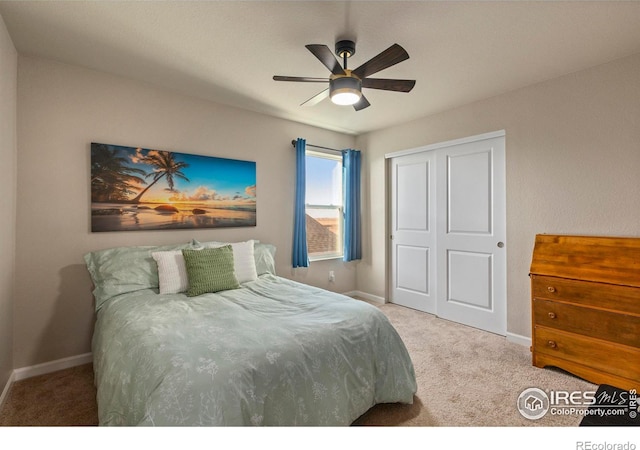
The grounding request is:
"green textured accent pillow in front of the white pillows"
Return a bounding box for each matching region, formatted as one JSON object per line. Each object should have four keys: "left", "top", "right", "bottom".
{"left": 182, "top": 245, "right": 240, "bottom": 297}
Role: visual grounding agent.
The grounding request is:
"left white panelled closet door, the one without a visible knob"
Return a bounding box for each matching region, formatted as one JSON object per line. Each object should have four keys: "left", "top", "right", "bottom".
{"left": 390, "top": 152, "right": 436, "bottom": 313}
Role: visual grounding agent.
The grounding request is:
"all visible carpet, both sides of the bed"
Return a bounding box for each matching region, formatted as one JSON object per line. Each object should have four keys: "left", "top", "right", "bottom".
{"left": 0, "top": 304, "right": 596, "bottom": 427}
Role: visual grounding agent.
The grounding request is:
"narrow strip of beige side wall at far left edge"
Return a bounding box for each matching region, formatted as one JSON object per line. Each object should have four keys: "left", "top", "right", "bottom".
{"left": 0, "top": 16, "right": 18, "bottom": 394}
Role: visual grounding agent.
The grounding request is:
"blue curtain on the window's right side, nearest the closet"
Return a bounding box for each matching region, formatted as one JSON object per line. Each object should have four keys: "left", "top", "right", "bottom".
{"left": 342, "top": 150, "right": 362, "bottom": 261}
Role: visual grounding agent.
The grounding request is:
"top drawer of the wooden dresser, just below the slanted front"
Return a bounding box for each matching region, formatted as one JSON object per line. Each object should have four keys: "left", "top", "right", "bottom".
{"left": 531, "top": 275, "right": 640, "bottom": 316}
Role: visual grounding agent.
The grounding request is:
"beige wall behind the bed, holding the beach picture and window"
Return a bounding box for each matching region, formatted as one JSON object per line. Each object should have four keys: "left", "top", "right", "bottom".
{"left": 14, "top": 56, "right": 355, "bottom": 368}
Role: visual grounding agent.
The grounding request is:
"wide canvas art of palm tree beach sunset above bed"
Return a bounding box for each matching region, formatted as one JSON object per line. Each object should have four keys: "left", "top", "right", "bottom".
{"left": 91, "top": 143, "right": 256, "bottom": 231}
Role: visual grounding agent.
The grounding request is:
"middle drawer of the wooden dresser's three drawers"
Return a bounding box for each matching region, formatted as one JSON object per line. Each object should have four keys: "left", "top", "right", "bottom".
{"left": 533, "top": 298, "right": 640, "bottom": 347}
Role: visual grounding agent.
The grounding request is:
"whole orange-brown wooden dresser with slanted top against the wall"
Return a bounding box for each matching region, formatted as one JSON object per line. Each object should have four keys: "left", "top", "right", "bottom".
{"left": 530, "top": 234, "right": 640, "bottom": 389}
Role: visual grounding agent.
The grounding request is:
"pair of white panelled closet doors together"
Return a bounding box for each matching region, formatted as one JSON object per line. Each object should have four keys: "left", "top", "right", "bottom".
{"left": 387, "top": 132, "right": 507, "bottom": 335}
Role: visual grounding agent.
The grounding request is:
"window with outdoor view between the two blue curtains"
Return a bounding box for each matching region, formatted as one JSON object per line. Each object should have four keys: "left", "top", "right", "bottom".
{"left": 305, "top": 150, "right": 343, "bottom": 261}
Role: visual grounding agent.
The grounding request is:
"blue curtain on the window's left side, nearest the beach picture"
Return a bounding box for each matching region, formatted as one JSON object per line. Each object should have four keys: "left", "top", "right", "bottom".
{"left": 291, "top": 138, "right": 309, "bottom": 267}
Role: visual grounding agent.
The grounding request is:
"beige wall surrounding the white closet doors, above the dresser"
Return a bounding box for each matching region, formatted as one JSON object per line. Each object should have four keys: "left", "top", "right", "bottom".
{"left": 356, "top": 51, "right": 640, "bottom": 336}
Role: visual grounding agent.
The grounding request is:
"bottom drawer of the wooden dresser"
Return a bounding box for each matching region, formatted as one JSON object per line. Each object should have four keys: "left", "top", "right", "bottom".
{"left": 533, "top": 326, "right": 640, "bottom": 380}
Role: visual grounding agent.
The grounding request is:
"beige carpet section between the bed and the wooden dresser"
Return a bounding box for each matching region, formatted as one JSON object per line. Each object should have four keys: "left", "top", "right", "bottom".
{"left": 356, "top": 304, "right": 597, "bottom": 427}
